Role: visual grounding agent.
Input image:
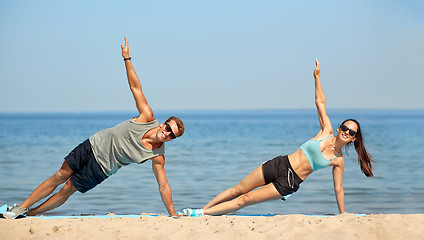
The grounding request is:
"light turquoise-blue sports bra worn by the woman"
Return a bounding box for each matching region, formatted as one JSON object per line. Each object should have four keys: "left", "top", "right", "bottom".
{"left": 300, "top": 135, "right": 341, "bottom": 172}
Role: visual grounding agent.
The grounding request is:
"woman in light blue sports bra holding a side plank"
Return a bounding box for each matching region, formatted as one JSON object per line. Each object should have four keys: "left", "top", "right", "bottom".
{"left": 183, "top": 60, "right": 373, "bottom": 217}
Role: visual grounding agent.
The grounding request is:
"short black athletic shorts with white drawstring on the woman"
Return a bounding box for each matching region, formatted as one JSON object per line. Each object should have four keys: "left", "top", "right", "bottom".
{"left": 262, "top": 156, "right": 303, "bottom": 200}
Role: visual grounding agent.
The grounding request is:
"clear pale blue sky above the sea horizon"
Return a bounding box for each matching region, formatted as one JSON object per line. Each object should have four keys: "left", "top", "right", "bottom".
{"left": 0, "top": 0, "right": 424, "bottom": 111}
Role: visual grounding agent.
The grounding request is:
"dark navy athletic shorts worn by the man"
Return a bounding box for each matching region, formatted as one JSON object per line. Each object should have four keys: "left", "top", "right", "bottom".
{"left": 65, "top": 139, "right": 107, "bottom": 193}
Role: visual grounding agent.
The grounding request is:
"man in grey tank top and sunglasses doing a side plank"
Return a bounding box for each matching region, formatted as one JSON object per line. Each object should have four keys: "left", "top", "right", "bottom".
{"left": 0, "top": 38, "right": 184, "bottom": 218}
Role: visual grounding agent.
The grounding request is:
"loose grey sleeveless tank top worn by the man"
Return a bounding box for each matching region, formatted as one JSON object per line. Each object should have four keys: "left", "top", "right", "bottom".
{"left": 90, "top": 120, "right": 165, "bottom": 176}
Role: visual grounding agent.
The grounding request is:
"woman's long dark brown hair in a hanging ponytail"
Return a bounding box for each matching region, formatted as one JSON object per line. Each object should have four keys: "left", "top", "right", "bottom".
{"left": 342, "top": 119, "right": 374, "bottom": 177}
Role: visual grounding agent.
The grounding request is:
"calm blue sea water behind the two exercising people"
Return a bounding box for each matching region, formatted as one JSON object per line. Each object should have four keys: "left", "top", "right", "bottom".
{"left": 0, "top": 110, "right": 424, "bottom": 215}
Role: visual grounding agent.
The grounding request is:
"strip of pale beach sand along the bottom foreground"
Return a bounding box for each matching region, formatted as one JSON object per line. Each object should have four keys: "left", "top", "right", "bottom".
{"left": 0, "top": 214, "right": 424, "bottom": 240}
